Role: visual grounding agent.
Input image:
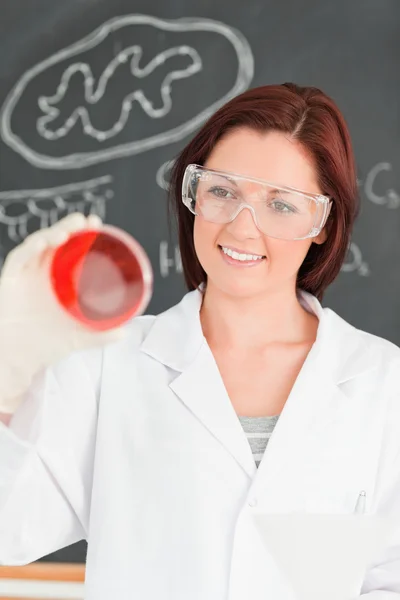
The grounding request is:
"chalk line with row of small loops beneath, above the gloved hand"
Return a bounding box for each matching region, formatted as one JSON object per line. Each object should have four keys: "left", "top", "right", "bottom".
{"left": 0, "top": 175, "right": 114, "bottom": 243}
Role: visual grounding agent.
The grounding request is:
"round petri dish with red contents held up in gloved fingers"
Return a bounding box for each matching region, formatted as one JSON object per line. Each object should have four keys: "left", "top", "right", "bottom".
{"left": 50, "top": 225, "right": 153, "bottom": 331}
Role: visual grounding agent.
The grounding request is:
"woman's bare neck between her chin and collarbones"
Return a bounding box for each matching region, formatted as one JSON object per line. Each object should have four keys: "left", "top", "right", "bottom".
{"left": 200, "top": 283, "right": 318, "bottom": 351}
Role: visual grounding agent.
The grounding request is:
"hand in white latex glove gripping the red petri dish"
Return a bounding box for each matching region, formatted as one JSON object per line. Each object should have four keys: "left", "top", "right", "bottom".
{"left": 0, "top": 213, "right": 124, "bottom": 413}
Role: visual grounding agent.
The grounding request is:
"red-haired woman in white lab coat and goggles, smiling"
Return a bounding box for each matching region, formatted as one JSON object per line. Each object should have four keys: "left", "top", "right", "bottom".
{"left": 0, "top": 84, "right": 400, "bottom": 600}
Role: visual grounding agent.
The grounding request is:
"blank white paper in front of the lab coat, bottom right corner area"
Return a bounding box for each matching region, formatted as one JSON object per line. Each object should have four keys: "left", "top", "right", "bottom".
{"left": 253, "top": 510, "right": 390, "bottom": 600}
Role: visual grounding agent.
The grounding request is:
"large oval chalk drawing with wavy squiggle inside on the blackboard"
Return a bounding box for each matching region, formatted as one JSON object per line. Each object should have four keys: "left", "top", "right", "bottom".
{"left": 0, "top": 15, "right": 254, "bottom": 170}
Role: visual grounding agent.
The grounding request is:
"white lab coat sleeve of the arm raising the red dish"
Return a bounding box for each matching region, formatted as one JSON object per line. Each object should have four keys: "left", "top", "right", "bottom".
{"left": 0, "top": 349, "right": 102, "bottom": 565}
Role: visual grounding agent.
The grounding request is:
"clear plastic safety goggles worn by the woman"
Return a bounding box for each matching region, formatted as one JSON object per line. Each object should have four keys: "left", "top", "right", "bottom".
{"left": 182, "top": 165, "right": 332, "bottom": 240}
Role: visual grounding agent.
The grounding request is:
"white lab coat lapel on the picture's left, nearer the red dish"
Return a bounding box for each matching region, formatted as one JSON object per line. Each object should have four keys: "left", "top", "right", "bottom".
{"left": 141, "top": 290, "right": 256, "bottom": 477}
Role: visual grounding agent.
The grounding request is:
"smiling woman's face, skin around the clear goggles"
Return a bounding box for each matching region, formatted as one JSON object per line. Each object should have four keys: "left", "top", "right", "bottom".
{"left": 193, "top": 128, "right": 326, "bottom": 297}
